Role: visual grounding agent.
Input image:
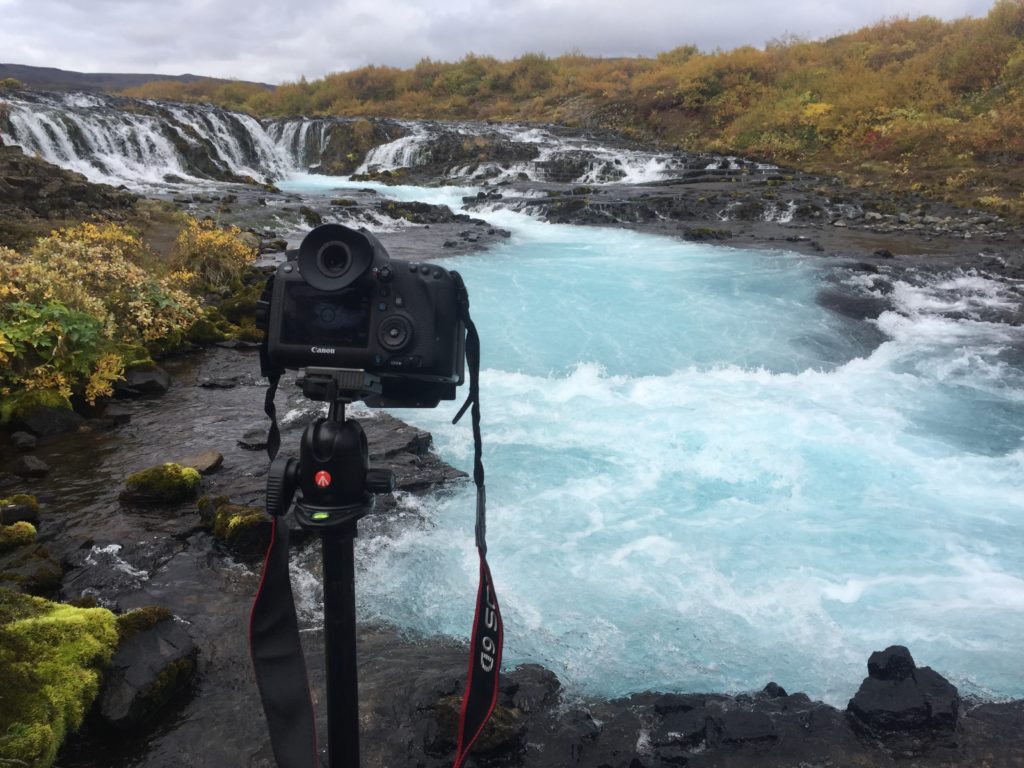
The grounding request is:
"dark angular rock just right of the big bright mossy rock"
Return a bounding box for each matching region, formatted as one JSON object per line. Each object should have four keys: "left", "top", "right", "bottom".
{"left": 97, "top": 614, "right": 198, "bottom": 729}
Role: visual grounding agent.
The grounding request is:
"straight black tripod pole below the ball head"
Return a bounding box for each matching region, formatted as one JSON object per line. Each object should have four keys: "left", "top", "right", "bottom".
{"left": 322, "top": 522, "right": 359, "bottom": 768}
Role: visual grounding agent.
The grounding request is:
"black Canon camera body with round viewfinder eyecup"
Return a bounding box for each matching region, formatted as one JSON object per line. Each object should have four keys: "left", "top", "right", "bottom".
{"left": 258, "top": 224, "right": 466, "bottom": 408}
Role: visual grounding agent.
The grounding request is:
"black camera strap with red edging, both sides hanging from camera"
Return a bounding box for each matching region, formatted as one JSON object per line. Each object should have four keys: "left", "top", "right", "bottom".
{"left": 249, "top": 272, "right": 504, "bottom": 768}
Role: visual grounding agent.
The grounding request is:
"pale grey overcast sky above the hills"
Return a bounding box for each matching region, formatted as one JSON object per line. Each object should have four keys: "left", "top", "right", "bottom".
{"left": 0, "top": 0, "right": 993, "bottom": 83}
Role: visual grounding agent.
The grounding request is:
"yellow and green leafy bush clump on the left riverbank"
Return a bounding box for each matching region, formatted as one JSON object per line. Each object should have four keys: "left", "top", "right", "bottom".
{"left": 0, "top": 219, "right": 255, "bottom": 422}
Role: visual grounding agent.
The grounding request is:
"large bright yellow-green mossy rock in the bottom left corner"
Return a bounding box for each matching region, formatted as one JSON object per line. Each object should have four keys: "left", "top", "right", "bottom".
{"left": 0, "top": 589, "right": 118, "bottom": 768}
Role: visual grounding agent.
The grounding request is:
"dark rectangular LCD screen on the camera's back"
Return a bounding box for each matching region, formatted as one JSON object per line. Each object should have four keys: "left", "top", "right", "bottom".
{"left": 281, "top": 283, "right": 370, "bottom": 347}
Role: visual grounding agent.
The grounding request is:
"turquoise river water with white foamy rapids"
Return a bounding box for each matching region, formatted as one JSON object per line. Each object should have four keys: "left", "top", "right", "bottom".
{"left": 270, "top": 176, "right": 1024, "bottom": 706}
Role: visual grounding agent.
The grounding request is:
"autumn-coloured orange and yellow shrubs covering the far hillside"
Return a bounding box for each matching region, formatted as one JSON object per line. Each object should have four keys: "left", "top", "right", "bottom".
{"left": 128, "top": 0, "right": 1024, "bottom": 217}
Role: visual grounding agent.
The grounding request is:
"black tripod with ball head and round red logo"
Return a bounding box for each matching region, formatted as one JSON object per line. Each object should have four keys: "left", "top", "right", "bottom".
{"left": 260, "top": 368, "right": 395, "bottom": 768}
